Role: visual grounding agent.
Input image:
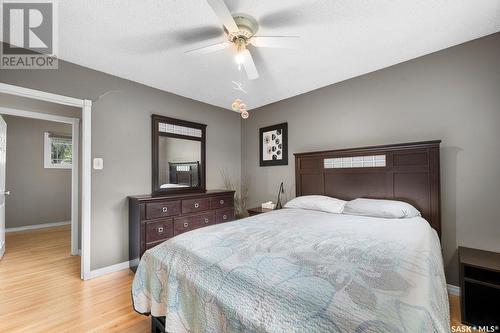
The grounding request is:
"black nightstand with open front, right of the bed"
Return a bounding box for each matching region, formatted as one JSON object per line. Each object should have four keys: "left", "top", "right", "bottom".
{"left": 458, "top": 247, "right": 500, "bottom": 326}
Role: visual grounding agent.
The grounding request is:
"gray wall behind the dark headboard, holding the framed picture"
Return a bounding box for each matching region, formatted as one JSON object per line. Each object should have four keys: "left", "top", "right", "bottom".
{"left": 242, "top": 34, "right": 500, "bottom": 284}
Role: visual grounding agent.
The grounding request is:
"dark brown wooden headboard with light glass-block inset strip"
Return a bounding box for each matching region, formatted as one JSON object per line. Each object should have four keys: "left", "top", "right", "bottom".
{"left": 294, "top": 140, "right": 441, "bottom": 237}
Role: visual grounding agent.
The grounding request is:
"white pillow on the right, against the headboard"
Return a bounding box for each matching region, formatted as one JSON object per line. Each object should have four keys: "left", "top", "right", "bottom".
{"left": 343, "top": 198, "right": 421, "bottom": 219}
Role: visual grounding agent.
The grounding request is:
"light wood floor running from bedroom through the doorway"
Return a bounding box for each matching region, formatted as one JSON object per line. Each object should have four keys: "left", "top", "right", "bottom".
{"left": 0, "top": 226, "right": 461, "bottom": 333}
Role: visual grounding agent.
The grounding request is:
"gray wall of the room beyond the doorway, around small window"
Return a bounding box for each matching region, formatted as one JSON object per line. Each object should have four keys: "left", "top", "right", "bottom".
{"left": 3, "top": 115, "right": 71, "bottom": 228}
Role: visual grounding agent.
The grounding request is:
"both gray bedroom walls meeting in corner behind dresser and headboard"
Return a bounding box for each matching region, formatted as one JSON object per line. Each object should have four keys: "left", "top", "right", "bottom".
{"left": 0, "top": 34, "right": 500, "bottom": 284}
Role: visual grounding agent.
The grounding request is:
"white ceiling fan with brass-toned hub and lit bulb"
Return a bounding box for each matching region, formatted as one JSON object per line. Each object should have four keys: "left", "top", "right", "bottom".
{"left": 185, "top": 0, "right": 299, "bottom": 80}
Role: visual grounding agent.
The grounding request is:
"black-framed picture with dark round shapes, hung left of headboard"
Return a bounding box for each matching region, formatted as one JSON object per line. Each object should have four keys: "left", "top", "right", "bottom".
{"left": 259, "top": 123, "right": 288, "bottom": 166}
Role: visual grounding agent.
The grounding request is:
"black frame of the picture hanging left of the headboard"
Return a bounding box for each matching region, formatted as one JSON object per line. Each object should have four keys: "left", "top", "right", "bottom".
{"left": 259, "top": 123, "right": 288, "bottom": 166}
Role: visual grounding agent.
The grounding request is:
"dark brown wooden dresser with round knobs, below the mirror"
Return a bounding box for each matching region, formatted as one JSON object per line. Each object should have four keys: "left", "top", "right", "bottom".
{"left": 129, "top": 191, "right": 234, "bottom": 271}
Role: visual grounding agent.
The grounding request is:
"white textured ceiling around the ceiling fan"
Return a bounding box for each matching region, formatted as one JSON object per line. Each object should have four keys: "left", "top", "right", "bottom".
{"left": 47, "top": 0, "right": 500, "bottom": 109}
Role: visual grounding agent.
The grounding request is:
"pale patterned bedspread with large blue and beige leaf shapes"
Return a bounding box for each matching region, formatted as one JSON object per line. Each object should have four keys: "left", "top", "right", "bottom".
{"left": 132, "top": 209, "right": 450, "bottom": 333}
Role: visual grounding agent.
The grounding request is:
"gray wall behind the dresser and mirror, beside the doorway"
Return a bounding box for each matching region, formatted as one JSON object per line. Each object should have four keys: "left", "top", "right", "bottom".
{"left": 0, "top": 61, "right": 241, "bottom": 269}
